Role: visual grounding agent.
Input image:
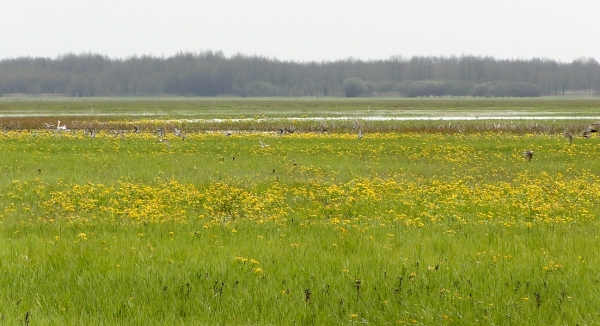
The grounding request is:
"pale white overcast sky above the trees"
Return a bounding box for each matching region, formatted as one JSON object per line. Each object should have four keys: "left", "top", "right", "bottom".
{"left": 0, "top": 0, "right": 600, "bottom": 62}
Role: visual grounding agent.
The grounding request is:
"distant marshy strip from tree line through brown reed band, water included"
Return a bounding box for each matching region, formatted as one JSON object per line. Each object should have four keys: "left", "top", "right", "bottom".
{"left": 0, "top": 97, "right": 600, "bottom": 133}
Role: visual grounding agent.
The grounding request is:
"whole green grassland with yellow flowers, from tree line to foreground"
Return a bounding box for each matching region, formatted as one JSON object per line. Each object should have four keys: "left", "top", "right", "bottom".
{"left": 0, "top": 98, "right": 600, "bottom": 325}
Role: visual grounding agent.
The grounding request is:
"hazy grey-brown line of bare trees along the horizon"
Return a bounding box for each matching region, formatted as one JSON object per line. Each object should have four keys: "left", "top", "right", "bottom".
{"left": 0, "top": 51, "right": 600, "bottom": 97}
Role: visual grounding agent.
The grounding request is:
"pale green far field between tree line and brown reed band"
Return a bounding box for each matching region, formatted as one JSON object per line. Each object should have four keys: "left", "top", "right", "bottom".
{"left": 0, "top": 97, "right": 600, "bottom": 119}
